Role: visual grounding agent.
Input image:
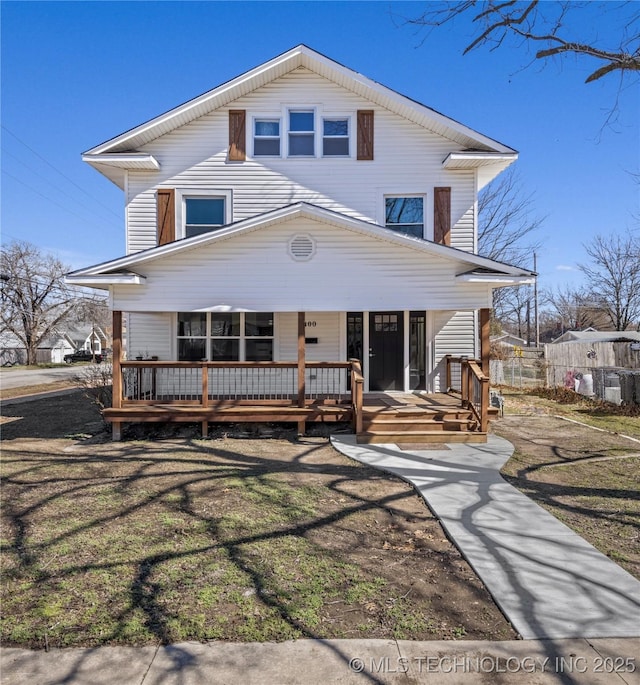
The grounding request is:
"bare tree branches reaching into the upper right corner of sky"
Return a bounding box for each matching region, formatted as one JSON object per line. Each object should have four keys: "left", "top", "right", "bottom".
{"left": 405, "top": 0, "right": 640, "bottom": 83}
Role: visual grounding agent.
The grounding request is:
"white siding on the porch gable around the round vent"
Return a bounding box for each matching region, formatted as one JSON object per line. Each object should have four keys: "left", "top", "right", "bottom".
{"left": 114, "top": 218, "right": 491, "bottom": 312}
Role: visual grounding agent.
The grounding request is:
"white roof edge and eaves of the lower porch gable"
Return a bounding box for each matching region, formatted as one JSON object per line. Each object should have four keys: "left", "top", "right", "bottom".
{"left": 65, "top": 202, "right": 535, "bottom": 288}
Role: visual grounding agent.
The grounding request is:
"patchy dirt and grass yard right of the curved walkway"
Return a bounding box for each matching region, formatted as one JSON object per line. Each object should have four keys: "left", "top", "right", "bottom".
{"left": 492, "top": 412, "right": 640, "bottom": 578}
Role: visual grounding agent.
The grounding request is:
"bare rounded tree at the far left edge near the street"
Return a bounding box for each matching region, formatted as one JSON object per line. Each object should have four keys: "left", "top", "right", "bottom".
{"left": 0, "top": 241, "right": 77, "bottom": 364}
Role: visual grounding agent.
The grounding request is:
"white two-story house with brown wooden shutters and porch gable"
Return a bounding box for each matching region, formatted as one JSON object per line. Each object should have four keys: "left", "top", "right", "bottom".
{"left": 67, "top": 46, "right": 534, "bottom": 438}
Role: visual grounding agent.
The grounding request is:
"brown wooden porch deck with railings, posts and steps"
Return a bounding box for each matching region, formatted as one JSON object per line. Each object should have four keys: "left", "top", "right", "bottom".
{"left": 104, "top": 309, "right": 489, "bottom": 443}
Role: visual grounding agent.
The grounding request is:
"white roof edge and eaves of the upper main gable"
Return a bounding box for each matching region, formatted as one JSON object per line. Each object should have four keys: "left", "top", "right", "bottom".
{"left": 83, "top": 45, "right": 517, "bottom": 185}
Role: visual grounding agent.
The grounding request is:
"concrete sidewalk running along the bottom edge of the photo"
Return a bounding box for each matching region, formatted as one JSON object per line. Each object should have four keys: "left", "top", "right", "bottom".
{"left": 0, "top": 638, "right": 640, "bottom": 685}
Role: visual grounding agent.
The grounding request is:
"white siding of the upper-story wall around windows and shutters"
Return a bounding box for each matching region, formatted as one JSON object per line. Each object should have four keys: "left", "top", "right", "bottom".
{"left": 127, "top": 69, "right": 475, "bottom": 253}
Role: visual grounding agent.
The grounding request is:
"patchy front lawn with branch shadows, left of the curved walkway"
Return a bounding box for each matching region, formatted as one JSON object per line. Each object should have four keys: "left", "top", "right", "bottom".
{"left": 1, "top": 393, "right": 516, "bottom": 647}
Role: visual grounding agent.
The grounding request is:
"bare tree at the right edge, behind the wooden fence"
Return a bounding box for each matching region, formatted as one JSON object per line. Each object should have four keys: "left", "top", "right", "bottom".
{"left": 578, "top": 231, "right": 640, "bottom": 331}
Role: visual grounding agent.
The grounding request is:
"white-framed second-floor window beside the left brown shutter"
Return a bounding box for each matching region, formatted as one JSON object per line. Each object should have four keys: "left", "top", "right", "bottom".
{"left": 176, "top": 188, "right": 232, "bottom": 238}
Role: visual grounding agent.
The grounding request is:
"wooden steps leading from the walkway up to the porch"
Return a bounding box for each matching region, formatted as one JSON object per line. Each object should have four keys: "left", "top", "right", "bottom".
{"left": 357, "top": 402, "right": 486, "bottom": 444}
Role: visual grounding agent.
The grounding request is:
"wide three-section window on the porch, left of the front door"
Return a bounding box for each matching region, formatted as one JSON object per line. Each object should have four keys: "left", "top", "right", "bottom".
{"left": 177, "top": 312, "right": 274, "bottom": 362}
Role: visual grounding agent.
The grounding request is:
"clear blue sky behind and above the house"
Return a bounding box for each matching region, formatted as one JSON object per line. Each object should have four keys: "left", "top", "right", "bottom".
{"left": 0, "top": 1, "right": 640, "bottom": 288}
